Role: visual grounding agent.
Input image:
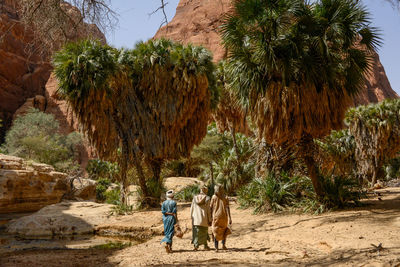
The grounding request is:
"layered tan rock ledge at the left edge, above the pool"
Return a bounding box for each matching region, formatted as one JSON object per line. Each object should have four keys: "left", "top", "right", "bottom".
{"left": 0, "top": 154, "right": 71, "bottom": 213}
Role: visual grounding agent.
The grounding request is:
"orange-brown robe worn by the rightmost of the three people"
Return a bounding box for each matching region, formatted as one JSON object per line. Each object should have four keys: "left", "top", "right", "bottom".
{"left": 210, "top": 195, "right": 229, "bottom": 241}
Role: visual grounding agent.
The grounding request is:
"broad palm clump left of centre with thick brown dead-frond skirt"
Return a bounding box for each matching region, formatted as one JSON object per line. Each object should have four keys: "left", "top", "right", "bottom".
{"left": 54, "top": 40, "right": 217, "bottom": 204}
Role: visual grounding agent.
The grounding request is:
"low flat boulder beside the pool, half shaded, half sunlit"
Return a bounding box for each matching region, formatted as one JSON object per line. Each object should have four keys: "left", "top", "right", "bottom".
{"left": 6, "top": 202, "right": 112, "bottom": 237}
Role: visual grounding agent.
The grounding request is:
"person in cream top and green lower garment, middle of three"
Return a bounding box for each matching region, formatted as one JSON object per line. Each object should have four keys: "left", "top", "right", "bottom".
{"left": 190, "top": 186, "right": 211, "bottom": 250}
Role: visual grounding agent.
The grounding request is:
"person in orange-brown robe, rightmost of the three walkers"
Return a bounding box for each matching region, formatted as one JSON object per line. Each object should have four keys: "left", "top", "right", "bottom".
{"left": 210, "top": 185, "right": 232, "bottom": 251}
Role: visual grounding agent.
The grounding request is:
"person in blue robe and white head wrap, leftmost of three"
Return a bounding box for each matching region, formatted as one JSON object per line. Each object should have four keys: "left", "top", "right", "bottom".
{"left": 161, "top": 190, "right": 178, "bottom": 253}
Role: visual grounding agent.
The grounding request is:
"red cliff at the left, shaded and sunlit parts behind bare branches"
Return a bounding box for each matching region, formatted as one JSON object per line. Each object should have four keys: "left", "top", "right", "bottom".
{"left": 0, "top": 0, "right": 106, "bottom": 162}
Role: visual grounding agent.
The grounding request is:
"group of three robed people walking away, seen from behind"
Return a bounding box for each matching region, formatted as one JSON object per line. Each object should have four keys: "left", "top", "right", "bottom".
{"left": 161, "top": 185, "right": 232, "bottom": 253}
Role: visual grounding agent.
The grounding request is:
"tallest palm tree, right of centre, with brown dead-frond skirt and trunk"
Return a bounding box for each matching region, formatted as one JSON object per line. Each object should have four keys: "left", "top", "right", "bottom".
{"left": 221, "top": 0, "right": 379, "bottom": 196}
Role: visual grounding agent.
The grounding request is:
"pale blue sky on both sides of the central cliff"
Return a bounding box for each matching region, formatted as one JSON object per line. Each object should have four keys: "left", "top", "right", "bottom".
{"left": 107, "top": 0, "right": 400, "bottom": 95}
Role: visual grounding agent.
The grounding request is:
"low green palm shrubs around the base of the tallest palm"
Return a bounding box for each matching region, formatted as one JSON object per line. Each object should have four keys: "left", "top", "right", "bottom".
{"left": 238, "top": 173, "right": 366, "bottom": 214}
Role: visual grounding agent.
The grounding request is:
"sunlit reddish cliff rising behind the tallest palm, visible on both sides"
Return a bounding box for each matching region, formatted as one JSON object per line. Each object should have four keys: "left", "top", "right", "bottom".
{"left": 154, "top": 0, "right": 399, "bottom": 105}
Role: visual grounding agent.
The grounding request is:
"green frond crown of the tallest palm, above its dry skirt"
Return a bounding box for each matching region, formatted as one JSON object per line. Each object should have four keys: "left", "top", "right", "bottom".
{"left": 221, "top": 0, "right": 380, "bottom": 109}
